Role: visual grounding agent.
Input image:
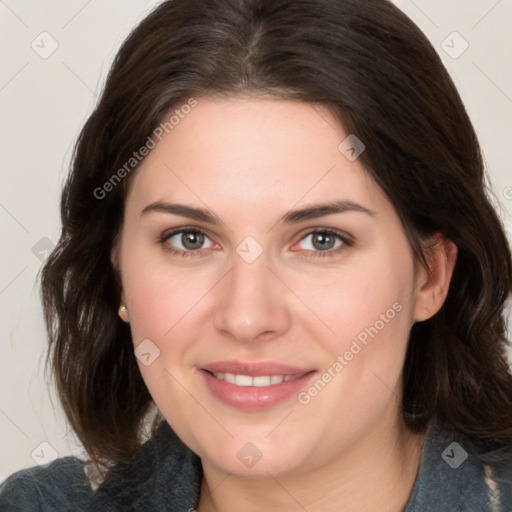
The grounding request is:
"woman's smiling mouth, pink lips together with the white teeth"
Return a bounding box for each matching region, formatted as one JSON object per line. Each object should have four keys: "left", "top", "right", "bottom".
{"left": 197, "top": 361, "right": 317, "bottom": 411}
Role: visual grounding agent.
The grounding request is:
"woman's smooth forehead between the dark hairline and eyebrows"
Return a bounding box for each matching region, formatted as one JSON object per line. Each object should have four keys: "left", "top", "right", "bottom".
{"left": 128, "top": 97, "right": 385, "bottom": 222}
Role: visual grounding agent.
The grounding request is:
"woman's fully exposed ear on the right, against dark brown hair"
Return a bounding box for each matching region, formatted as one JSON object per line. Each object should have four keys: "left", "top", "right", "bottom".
{"left": 414, "top": 233, "right": 457, "bottom": 322}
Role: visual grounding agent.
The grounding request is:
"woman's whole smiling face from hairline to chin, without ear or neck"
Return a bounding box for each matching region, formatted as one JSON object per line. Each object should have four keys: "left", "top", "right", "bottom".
{"left": 115, "top": 97, "right": 428, "bottom": 476}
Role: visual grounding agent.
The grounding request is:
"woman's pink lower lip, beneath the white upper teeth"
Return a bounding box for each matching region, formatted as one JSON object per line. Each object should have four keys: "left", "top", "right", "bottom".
{"left": 200, "top": 370, "right": 316, "bottom": 411}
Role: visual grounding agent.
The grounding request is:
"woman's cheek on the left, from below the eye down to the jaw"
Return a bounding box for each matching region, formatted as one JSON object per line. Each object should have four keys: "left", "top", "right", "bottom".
{"left": 123, "top": 253, "right": 209, "bottom": 444}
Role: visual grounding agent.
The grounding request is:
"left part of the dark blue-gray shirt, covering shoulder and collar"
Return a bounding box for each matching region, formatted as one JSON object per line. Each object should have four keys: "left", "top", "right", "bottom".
{"left": 0, "top": 422, "right": 202, "bottom": 512}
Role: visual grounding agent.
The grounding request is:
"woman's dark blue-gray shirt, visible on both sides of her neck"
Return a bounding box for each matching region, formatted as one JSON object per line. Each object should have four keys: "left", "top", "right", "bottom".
{"left": 0, "top": 414, "right": 512, "bottom": 512}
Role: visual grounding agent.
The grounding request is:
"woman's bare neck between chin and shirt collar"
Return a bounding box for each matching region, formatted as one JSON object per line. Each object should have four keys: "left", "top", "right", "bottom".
{"left": 198, "top": 418, "right": 425, "bottom": 512}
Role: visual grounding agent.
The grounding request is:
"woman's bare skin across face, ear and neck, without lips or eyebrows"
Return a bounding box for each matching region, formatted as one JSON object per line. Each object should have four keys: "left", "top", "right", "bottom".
{"left": 112, "top": 96, "right": 456, "bottom": 512}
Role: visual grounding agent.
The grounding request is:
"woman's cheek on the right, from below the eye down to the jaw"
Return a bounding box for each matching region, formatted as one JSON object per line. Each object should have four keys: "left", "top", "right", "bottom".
{"left": 301, "top": 241, "right": 414, "bottom": 431}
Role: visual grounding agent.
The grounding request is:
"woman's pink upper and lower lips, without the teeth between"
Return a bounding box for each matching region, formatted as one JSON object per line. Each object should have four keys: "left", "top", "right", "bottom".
{"left": 198, "top": 361, "right": 317, "bottom": 411}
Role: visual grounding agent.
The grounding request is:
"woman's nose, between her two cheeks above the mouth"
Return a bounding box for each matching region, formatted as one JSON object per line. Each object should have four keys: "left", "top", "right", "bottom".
{"left": 214, "top": 249, "right": 290, "bottom": 343}
